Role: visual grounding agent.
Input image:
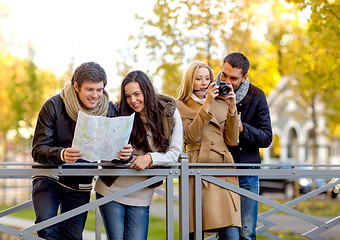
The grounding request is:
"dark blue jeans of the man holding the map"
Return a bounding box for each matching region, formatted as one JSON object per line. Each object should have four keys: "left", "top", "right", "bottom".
{"left": 32, "top": 178, "right": 90, "bottom": 240}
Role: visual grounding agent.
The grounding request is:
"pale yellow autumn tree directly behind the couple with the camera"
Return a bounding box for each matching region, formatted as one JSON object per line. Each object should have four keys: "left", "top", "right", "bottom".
{"left": 120, "top": 0, "right": 286, "bottom": 96}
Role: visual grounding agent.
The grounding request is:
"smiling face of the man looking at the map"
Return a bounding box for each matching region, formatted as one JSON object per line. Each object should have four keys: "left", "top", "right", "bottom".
{"left": 74, "top": 81, "right": 104, "bottom": 109}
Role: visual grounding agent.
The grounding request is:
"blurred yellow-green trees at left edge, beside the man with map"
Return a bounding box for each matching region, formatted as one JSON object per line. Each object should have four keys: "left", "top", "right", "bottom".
{"left": 0, "top": 1, "right": 63, "bottom": 160}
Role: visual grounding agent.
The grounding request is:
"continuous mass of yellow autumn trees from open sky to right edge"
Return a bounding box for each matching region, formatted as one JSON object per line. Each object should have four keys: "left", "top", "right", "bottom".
{"left": 118, "top": 0, "right": 340, "bottom": 135}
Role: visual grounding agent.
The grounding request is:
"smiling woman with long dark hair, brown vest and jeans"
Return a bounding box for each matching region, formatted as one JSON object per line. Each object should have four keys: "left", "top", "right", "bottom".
{"left": 95, "top": 70, "right": 183, "bottom": 240}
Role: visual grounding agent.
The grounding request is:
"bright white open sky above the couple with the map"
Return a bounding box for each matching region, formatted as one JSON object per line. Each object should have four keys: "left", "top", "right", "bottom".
{"left": 0, "top": 0, "right": 155, "bottom": 92}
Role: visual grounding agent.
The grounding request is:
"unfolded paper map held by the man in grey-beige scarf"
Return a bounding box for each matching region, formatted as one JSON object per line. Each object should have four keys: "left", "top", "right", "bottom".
{"left": 72, "top": 112, "right": 135, "bottom": 161}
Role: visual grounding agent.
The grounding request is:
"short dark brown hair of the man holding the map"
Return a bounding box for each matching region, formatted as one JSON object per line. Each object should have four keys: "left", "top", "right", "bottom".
{"left": 71, "top": 62, "right": 107, "bottom": 88}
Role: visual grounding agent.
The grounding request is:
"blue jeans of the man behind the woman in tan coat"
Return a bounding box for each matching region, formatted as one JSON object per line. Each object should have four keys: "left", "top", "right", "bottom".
{"left": 238, "top": 176, "right": 259, "bottom": 240}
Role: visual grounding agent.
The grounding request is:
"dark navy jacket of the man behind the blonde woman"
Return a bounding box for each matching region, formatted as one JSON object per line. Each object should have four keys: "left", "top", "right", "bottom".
{"left": 229, "top": 84, "right": 273, "bottom": 168}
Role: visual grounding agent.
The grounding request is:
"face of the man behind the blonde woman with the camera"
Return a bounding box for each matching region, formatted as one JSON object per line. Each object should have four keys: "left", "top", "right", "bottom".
{"left": 221, "top": 62, "right": 248, "bottom": 91}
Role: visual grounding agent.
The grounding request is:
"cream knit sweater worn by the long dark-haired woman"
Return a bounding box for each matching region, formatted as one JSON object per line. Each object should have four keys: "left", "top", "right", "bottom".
{"left": 94, "top": 109, "right": 183, "bottom": 206}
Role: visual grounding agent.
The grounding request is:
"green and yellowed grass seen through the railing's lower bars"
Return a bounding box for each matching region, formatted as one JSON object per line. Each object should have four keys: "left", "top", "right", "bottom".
{"left": 0, "top": 199, "right": 340, "bottom": 240}
